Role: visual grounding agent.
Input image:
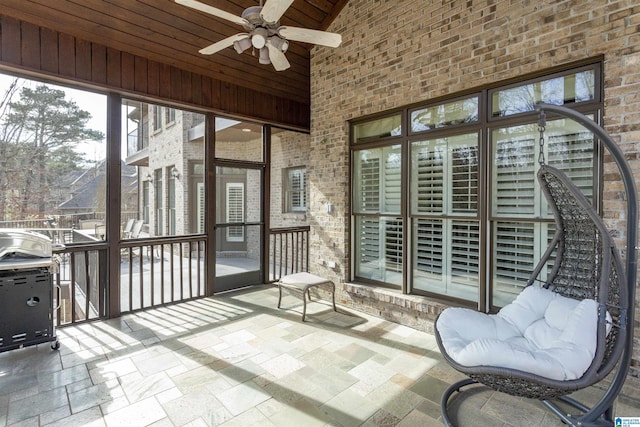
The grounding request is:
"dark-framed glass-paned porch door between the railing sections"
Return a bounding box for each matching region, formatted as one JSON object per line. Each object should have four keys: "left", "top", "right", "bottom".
{"left": 215, "top": 166, "right": 264, "bottom": 292}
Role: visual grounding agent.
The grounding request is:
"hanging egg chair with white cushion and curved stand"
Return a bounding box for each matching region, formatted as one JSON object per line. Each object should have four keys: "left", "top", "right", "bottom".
{"left": 435, "top": 106, "right": 637, "bottom": 426}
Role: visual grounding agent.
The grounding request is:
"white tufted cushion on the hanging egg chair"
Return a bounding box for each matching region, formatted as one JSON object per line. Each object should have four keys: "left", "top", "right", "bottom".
{"left": 436, "top": 286, "right": 598, "bottom": 380}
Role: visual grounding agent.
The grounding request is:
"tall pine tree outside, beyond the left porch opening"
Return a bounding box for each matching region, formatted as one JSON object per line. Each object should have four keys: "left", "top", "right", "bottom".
{"left": 0, "top": 84, "right": 104, "bottom": 218}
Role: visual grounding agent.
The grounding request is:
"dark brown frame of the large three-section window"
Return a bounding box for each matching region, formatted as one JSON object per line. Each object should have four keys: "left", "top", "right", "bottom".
{"left": 349, "top": 58, "right": 604, "bottom": 311}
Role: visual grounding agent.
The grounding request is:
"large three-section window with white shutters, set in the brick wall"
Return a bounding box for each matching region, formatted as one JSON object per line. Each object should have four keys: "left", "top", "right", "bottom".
{"left": 351, "top": 64, "right": 602, "bottom": 310}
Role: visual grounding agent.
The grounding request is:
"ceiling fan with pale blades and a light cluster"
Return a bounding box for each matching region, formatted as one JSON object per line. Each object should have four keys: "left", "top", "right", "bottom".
{"left": 175, "top": 0, "right": 342, "bottom": 71}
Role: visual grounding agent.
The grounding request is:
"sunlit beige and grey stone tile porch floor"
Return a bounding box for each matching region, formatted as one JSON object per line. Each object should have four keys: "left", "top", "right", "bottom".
{"left": 0, "top": 286, "right": 640, "bottom": 427}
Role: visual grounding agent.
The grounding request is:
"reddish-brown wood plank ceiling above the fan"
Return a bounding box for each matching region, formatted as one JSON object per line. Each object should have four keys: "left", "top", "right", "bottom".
{"left": 0, "top": 0, "right": 347, "bottom": 104}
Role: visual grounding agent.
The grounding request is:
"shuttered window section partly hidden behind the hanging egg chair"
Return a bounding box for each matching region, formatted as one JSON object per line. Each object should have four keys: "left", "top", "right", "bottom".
{"left": 492, "top": 120, "right": 595, "bottom": 306}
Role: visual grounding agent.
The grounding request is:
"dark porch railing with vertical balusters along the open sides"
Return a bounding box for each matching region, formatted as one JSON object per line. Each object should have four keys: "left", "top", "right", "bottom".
{"left": 32, "top": 224, "right": 309, "bottom": 326}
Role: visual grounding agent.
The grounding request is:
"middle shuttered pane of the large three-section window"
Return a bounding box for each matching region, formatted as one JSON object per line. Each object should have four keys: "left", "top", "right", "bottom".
{"left": 411, "top": 133, "right": 480, "bottom": 300}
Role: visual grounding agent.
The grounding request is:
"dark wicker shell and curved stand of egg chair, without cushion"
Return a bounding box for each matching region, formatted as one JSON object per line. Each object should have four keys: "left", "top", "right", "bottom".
{"left": 435, "top": 106, "right": 637, "bottom": 426}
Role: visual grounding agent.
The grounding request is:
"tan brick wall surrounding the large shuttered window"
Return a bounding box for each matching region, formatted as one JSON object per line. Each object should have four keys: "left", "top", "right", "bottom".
{"left": 309, "top": 0, "right": 640, "bottom": 397}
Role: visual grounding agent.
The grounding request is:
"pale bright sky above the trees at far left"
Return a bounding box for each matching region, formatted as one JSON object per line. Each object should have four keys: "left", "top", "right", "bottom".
{"left": 0, "top": 73, "right": 107, "bottom": 165}
